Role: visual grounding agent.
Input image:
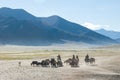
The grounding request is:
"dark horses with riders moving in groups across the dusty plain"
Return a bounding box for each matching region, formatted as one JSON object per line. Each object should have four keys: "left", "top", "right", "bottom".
{"left": 31, "top": 54, "right": 95, "bottom": 68}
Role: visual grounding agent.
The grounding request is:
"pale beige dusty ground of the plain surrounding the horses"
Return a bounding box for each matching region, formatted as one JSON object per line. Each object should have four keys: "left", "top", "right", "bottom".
{"left": 0, "top": 44, "right": 120, "bottom": 80}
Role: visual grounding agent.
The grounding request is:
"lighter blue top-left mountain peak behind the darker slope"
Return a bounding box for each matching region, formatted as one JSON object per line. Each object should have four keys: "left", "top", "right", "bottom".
{"left": 0, "top": 7, "right": 36, "bottom": 20}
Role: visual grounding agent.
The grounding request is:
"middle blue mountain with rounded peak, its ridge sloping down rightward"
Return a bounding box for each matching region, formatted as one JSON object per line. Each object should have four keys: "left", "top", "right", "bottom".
{"left": 41, "top": 15, "right": 116, "bottom": 43}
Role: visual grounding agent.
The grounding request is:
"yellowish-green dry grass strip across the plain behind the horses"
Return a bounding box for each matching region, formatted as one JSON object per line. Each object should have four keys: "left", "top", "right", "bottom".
{"left": 0, "top": 49, "right": 120, "bottom": 60}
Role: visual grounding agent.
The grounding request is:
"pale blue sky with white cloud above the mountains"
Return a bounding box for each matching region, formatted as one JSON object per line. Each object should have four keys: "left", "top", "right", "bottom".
{"left": 0, "top": 0, "right": 120, "bottom": 31}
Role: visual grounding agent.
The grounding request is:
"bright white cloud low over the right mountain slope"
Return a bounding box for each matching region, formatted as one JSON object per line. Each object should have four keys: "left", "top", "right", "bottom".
{"left": 82, "top": 22, "right": 110, "bottom": 30}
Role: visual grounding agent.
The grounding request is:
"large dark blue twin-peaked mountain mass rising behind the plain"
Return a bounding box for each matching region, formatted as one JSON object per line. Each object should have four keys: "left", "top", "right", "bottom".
{"left": 0, "top": 8, "right": 116, "bottom": 45}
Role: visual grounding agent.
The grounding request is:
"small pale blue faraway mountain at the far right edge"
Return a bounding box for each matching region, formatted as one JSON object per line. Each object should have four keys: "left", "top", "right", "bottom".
{"left": 96, "top": 29, "right": 120, "bottom": 39}
